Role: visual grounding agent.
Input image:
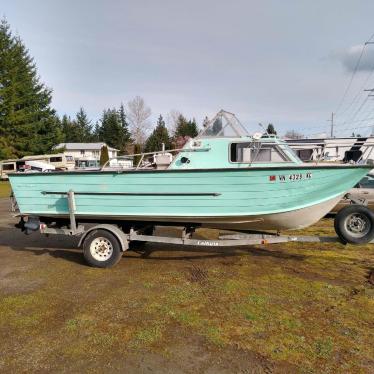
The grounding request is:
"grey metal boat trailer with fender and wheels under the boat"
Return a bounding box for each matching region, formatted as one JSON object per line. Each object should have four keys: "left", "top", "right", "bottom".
{"left": 16, "top": 190, "right": 374, "bottom": 268}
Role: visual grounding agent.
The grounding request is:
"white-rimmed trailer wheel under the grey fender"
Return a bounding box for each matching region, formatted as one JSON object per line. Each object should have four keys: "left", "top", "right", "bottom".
{"left": 83, "top": 229, "right": 122, "bottom": 268}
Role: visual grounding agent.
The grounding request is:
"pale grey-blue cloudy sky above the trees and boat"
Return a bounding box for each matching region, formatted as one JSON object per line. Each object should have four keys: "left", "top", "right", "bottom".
{"left": 0, "top": 0, "right": 374, "bottom": 134}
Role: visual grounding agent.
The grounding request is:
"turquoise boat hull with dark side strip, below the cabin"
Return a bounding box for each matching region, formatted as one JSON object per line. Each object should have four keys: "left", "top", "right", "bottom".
{"left": 10, "top": 165, "right": 370, "bottom": 230}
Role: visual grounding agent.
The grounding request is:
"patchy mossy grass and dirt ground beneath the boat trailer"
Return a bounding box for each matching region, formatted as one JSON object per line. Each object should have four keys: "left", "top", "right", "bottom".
{"left": 0, "top": 215, "right": 374, "bottom": 373}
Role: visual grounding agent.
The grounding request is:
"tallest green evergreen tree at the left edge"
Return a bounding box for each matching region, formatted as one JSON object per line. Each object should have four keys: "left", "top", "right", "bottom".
{"left": 0, "top": 19, "right": 63, "bottom": 156}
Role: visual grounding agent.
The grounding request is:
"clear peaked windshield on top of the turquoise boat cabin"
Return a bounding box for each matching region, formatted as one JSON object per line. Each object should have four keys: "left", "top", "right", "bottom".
{"left": 198, "top": 110, "right": 248, "bottom": 137}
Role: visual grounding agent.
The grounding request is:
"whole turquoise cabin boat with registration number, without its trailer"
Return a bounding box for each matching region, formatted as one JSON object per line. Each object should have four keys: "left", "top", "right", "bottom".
{"left": 9, "top": 110, "right": 372, "bottom": 231}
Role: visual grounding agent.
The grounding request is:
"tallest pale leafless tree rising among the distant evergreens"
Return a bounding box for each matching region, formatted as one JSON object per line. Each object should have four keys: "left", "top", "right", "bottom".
{"left": 127, "top": 96, "right": 152, "bottom": 144}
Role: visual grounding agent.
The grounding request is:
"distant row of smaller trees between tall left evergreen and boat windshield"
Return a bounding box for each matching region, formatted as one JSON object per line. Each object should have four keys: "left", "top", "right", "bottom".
{"left": 58, "top": 100, "right": 198, "bottom": 153}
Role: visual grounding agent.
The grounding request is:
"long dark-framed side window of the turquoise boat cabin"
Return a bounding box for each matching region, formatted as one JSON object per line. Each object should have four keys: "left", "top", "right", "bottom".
{"left": 230, "top": 143, "right": 289, "bottom": 163}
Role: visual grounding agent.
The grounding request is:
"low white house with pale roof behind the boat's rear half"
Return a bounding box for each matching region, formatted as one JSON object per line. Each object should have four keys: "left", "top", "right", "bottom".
{"left": 53, "top": 142, "right": 118, "bottom": 161}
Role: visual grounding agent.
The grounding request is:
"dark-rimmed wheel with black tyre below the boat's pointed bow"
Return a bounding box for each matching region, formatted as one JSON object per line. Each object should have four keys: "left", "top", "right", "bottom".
{"left": 334, "top": 204, "right": 374, "bottom": 244}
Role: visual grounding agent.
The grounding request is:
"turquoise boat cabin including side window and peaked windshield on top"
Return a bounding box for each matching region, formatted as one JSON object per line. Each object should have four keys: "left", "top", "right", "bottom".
{"left": 169, "top": 111, "right": 302, "bottom": 169}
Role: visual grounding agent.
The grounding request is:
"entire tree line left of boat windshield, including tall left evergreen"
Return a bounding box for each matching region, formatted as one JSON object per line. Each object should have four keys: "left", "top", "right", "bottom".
{"left": 0, "top": 19, "right": 198, "bottom": 159}
